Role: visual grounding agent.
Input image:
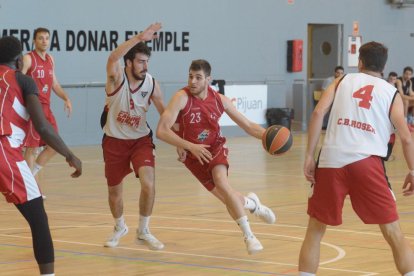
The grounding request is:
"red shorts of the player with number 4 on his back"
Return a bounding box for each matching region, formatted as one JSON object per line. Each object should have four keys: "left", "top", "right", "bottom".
{"left": 308, "top": 156, "right": 398, "bottom": 225}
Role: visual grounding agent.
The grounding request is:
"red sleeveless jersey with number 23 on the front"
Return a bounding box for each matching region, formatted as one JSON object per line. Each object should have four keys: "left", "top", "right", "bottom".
{"left": 176, "top": 87, "right": 226, "bottom": 147}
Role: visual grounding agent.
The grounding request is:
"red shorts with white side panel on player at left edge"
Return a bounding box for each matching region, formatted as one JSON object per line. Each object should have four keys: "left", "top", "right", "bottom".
{"left": 0, "top": 136, "right": 41, "bottom": 204}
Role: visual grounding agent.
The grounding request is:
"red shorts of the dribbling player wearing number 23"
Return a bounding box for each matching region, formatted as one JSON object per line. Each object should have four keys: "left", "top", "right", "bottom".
{"left": 184, "top": 145, "right": 229, "bottom": 191}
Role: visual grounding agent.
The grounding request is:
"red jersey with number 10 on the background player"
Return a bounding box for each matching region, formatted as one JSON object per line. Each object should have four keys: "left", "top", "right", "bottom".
{"left": 26, "top": 50, "right": 54, "bottom": 105}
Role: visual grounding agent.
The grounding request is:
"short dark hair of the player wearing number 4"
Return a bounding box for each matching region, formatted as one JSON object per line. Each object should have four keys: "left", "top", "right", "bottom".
{"left": 359, "top": 41, "right": 388, "bottom": 73}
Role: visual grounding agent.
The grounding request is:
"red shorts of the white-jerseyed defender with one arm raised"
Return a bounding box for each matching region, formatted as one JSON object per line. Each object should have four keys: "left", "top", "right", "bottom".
{"left": 102, "top": 134, "right": 155, "bottom": 186}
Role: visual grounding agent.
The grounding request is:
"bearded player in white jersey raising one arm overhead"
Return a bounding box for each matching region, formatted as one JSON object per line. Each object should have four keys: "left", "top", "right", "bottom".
{"left": 102, "top": 23, "right": 164, "bottom": 250}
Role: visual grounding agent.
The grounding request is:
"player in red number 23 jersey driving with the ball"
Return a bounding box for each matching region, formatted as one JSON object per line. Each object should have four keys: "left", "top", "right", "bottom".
{"left": 157, "top": 60, "right": 276, "bottom": 254}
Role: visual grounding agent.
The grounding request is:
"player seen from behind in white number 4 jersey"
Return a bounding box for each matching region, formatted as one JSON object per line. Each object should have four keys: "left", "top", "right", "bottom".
{"left": 299, "top": 42, "right": 414, "bottom": 276}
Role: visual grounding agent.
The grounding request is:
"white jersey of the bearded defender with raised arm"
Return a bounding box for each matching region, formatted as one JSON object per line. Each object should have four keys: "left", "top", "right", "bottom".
{"left": 103, "top": 73, "right": 154, "bottom": 139}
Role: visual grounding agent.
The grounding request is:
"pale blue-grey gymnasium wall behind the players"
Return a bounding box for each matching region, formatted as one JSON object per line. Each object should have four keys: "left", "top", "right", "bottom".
{"left": 0, "top": 0, "right": 414, "bottom": 145}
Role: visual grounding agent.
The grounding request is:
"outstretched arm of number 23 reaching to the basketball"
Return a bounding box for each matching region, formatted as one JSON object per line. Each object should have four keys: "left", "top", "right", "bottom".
{"left": 219, "top": 94, "right": 265, "bottom": 139}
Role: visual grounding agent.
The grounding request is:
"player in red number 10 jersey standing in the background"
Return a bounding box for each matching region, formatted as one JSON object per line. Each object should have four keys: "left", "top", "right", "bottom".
{"left": 22, "top": 28, "right": 72, "bottom": 196}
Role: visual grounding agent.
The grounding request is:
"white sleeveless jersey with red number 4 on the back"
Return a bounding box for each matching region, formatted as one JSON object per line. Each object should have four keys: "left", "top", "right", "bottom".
{"left": 318, "top": 73, "right": 397, "bottom": 168}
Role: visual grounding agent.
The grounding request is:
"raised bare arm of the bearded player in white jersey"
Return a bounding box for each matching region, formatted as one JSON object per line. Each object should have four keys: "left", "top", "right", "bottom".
{"left": 105, "top": 22, "right": 162, "bottom": 93}
